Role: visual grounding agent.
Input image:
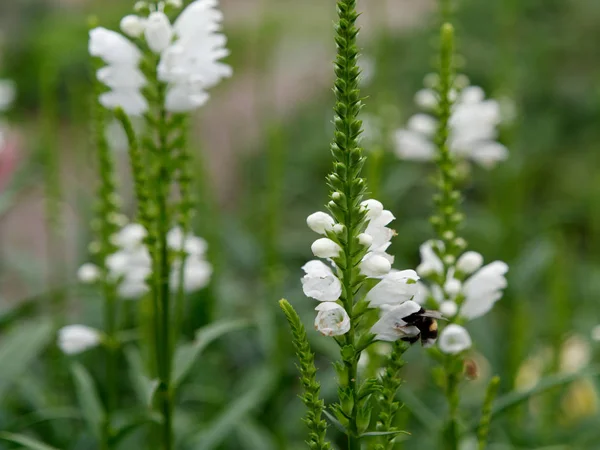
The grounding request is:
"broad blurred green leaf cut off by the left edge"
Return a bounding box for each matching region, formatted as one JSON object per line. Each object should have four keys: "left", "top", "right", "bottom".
{"left": 0, "top": 319, "right": 53, "bottom": 398}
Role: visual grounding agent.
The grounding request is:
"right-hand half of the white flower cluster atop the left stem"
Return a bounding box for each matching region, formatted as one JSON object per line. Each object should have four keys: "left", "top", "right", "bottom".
{"left": 158, "top": 0, "right": 232, "bottom": 112}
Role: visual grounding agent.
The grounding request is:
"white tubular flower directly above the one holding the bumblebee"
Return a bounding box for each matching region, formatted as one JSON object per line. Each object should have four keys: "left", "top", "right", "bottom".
{"left": 366, "top": 270, "right": 419, "bottom": 308}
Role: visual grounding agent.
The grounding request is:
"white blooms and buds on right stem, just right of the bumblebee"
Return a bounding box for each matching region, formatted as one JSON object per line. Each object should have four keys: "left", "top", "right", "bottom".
{"left": 414, "top": 241, "right": 508, "bottom": 354}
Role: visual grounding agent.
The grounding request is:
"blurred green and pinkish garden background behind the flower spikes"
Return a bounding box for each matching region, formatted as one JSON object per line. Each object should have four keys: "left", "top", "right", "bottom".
{"left": 0, "top": 0, "right": 600, "bottom": 450}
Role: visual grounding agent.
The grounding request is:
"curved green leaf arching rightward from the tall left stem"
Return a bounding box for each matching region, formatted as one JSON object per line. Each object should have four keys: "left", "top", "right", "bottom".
{"left": 173, "top": 320, "right": 251, "bottom": 386}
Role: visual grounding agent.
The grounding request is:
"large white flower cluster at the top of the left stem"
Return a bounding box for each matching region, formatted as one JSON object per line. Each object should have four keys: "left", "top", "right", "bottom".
{"left": 89, "top": 0, "right": 232, "bottom": 116}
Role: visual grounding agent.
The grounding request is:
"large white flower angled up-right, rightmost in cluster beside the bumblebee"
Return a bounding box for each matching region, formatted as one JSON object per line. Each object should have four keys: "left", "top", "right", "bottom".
{"left": 460, "top": 261, "right": 508, "bottom": 320}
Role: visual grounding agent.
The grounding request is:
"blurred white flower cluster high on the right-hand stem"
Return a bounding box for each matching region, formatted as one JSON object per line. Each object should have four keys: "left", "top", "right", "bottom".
{"left": 395, "top": 79, "right": 508, "bottom": 169}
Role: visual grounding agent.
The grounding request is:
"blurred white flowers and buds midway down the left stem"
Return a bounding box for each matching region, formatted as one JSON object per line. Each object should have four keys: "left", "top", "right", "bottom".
{"left": 78, "top": 223, "right": 212, "bottom": 299}
